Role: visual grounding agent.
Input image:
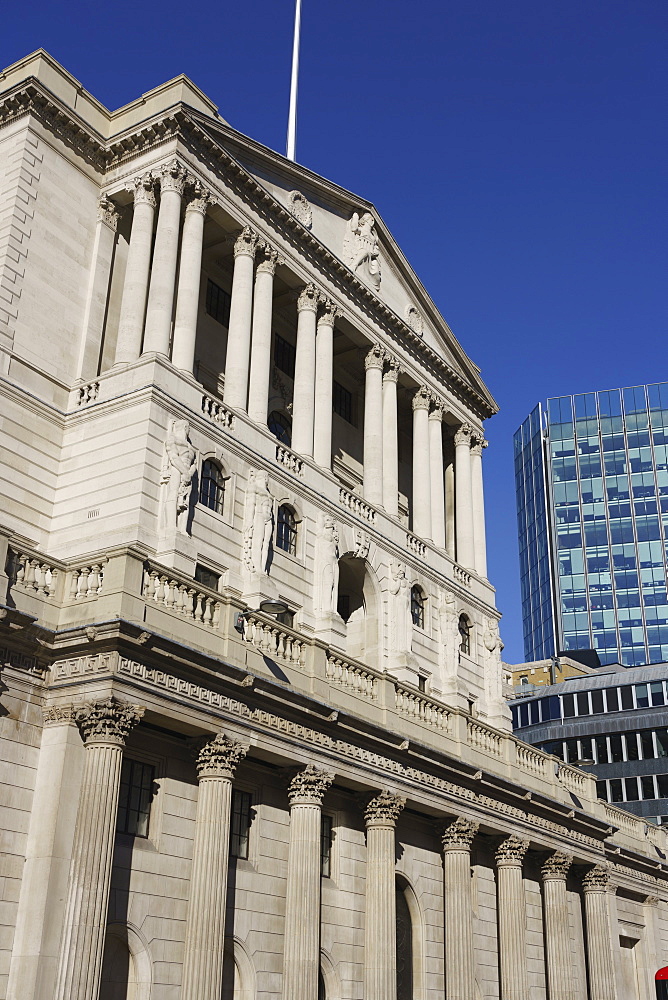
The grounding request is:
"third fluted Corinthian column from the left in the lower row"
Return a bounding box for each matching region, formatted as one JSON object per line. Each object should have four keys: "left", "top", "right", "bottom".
{"left": 283, "top": 764, "right": 334, "bottom": 1000}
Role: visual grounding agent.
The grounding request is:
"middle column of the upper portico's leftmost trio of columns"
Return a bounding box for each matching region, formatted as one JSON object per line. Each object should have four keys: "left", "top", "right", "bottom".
{"left": 143, "top": 160, "right": 186, "bottom": 355}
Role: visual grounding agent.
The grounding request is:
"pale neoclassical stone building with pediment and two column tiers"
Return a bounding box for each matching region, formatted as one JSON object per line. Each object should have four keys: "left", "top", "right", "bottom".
{"left": 0, "top": 51, "right": 668, "bottom": 1000}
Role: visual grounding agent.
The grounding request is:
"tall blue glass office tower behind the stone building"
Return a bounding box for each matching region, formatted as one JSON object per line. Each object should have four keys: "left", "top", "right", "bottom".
{"left": 514, "top": 382, "right": 668, "bottom": 666}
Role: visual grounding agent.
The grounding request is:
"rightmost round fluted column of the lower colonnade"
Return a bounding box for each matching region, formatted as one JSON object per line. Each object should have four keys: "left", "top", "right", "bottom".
{"left": 582, "top": 865, "right": 617, "bottom": 1000}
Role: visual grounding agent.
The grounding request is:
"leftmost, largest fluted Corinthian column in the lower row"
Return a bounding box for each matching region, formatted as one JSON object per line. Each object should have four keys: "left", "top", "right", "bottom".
{"left": 55, "top": 698, "right": 144, "bottom": 1000}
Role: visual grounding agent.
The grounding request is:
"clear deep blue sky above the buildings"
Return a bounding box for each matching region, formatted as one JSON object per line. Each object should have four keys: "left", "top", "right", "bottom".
{"left": 0, "top": 0, "right": 668, "bottom": 662}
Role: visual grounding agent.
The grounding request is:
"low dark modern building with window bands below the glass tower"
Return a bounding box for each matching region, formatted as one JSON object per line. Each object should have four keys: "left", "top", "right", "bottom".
{"left": 511, "top": 663, "right": 668, "bottom": 824}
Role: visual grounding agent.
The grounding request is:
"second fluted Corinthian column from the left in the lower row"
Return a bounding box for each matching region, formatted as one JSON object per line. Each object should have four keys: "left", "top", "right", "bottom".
{"left": 181, "top": 733, "right": 247, "bottom": 1000}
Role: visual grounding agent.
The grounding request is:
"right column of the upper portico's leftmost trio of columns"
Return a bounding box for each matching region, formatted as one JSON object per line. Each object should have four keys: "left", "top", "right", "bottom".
{"left": 172, "top": 182, "right": 210, "bottom": 375}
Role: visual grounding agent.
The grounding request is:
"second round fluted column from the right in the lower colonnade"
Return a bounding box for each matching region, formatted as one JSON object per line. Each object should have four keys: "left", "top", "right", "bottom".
{"left": 541, "top": 851, "right": 575, "bottom": 1000}
